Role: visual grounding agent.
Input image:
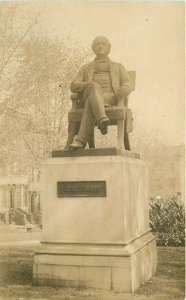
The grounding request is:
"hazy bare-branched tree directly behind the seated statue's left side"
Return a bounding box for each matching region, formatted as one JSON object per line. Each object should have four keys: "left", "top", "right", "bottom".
{"left": 0, "top": 29, "right": 87, "bottom": 165}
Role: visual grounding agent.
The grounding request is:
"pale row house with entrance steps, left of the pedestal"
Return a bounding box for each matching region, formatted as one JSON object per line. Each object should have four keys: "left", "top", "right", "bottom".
{"left": 0, "top": 162, "right": 41, "bottom": 225}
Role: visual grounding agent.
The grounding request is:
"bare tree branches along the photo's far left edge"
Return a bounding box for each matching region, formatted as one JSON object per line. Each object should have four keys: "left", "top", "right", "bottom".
{"left": 0, "top": 2, "right": 40, "bottom": 164}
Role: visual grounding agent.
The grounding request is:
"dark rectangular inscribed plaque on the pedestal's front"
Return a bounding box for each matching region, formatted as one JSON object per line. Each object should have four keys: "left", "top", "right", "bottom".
{"left": 57, "top": 181, "right": 106, "bottom": 198}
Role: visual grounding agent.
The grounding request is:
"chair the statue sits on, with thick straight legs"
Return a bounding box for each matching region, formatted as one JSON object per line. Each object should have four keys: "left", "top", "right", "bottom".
{"left": 65, "top": 71, "right": 136, "bottom": 150}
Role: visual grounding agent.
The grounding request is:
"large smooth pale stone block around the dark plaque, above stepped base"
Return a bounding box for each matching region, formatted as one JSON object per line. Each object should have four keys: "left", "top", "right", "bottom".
{"left": 42, "top": 151, "right": 149, "bottom": 244}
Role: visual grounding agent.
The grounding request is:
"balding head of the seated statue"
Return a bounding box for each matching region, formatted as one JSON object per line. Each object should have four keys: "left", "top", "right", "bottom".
{"left": 92, "top": 36, "right": 111, "bottom": 56}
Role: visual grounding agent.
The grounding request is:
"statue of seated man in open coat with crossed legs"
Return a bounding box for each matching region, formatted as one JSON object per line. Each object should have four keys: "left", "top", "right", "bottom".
{"left": 70, "top": 36, "right": 132, "bottom": 149}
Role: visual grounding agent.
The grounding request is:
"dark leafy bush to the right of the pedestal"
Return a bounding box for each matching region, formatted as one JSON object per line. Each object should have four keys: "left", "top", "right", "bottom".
{"left": 149, "top": 193, "right": 185, "bottom": 246}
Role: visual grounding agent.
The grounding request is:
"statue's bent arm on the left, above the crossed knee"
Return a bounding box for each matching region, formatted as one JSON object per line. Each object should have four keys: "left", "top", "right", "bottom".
{"left": 70, "top": 66, "right": 90, "bottom": 93}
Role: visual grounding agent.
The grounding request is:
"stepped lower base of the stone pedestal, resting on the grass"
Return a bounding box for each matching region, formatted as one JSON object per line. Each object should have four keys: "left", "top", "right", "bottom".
{"left": 33, "top": 233, "right": 157, "bottom": 293}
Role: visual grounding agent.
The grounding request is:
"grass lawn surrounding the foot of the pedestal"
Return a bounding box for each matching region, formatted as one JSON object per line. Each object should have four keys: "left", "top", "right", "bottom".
{"left": 0, "top": 244, "right": 184, "bottom": 300}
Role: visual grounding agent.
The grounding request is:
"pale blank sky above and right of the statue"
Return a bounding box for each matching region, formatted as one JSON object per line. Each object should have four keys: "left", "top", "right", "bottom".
{"left": 5, "top": 1, "right": 184, "bottom": 145}
